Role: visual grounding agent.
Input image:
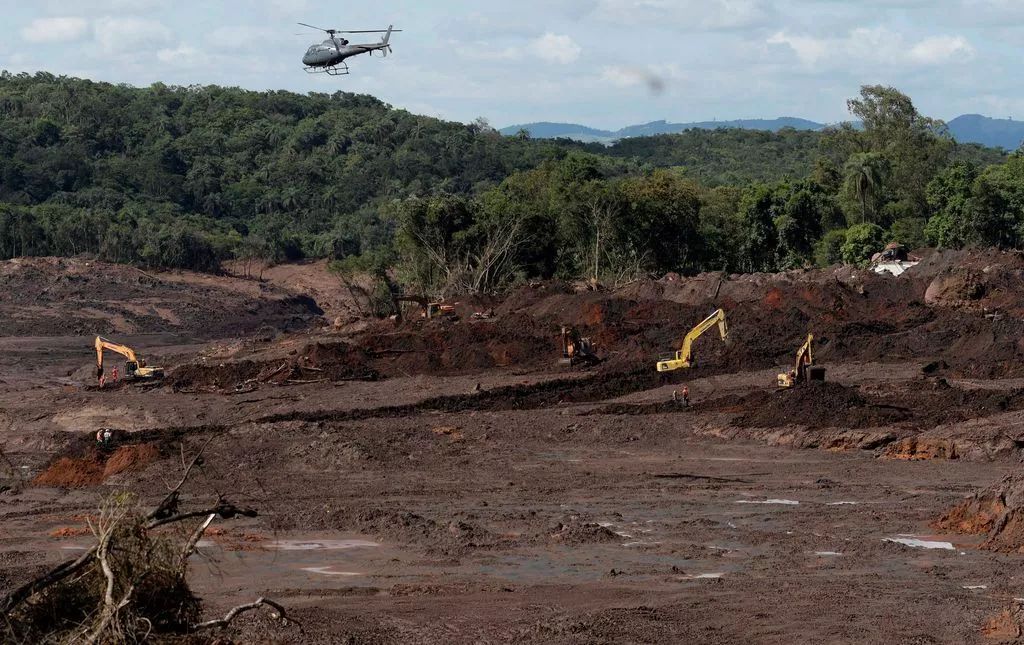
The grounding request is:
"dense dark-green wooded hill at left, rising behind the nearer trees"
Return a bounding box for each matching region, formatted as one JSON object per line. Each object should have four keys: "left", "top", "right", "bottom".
{"left": 0, "top": 73, "right": 593, "bottom": 268}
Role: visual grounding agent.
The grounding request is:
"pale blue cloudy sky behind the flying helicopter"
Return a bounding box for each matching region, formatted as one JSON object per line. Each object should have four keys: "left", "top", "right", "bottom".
{"left": 0, "top": 0, "right": 1024, "bottom": 129}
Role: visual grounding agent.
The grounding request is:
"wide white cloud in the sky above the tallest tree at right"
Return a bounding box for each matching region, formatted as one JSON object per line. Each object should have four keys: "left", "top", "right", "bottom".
{"left": 766, "top": 27, "right": 975, "bottom": 69}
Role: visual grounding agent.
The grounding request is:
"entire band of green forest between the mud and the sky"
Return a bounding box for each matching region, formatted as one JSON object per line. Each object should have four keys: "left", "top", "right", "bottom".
{"left": 0, "top": 74, "right": 1024, "bottom": 301}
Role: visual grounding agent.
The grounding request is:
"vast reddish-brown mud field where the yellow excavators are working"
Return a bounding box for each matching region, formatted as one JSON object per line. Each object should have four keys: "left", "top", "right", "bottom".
{"left": 0, "top": 252, "right": 1024, "bottom": 643}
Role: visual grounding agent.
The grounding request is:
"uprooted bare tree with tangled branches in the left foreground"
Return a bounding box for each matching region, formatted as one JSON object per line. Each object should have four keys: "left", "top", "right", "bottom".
{"left": 0, "top": 438, "right": 289, "bottom": 643}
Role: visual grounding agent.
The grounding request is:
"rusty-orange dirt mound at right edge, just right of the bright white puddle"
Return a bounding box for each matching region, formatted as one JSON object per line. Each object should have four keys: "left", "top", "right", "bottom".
{"left": 932, "top": 475, "right": 1024, "bottom": 553}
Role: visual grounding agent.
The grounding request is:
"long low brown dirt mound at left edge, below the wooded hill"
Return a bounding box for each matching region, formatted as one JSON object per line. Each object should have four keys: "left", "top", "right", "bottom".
{"left": 0, "top": 258, "right": 323, "bottom": 339}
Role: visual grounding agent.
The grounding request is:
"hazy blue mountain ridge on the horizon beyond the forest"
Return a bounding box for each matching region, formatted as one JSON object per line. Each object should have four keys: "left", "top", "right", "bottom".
{"left": 500, "top": 115, "right": 1024, "bottom": 151}
